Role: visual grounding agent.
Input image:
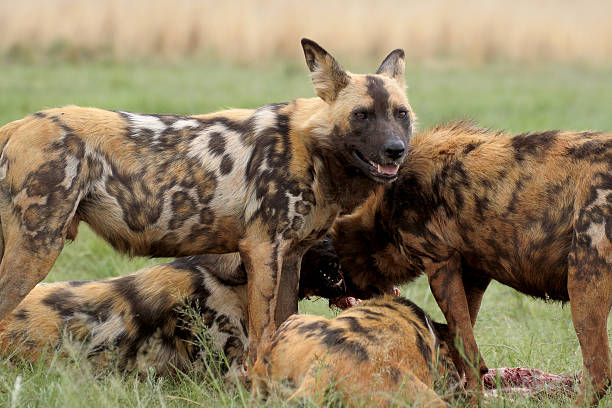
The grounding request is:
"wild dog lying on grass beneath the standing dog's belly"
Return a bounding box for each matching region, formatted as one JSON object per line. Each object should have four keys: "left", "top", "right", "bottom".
{"left": 0, "top": 242, "right": 344, "bottom": 374}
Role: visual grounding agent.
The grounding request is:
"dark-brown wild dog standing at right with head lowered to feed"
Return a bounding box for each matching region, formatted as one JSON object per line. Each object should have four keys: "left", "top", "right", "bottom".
{"left": 314, "top": 122, "right": 612, "bottom": 401}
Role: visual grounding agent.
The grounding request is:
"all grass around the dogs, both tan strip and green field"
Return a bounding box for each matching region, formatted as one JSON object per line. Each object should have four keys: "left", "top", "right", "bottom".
{"left": 0, "top": 0, "right": 612, "bottom": 407}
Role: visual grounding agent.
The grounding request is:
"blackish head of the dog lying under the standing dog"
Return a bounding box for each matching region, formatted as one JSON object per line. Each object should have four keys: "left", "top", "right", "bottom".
{"left": 299, "top": 237, "right": 346, "bottom": 299}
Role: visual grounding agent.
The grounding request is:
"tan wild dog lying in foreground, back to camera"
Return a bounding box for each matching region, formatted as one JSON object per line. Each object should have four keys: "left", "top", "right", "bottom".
{"left": 252, "top": 296, "right": 461, "bottom": 407}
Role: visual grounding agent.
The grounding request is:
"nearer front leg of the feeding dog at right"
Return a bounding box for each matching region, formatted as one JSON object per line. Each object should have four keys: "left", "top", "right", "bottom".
{"left": 426, "top": 253, "right": 484, "bottom": 402}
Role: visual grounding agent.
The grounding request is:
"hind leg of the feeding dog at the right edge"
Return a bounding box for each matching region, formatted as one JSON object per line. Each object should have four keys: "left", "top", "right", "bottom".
{"left": 567, "top": 197, "right": 612, "bottom": 404}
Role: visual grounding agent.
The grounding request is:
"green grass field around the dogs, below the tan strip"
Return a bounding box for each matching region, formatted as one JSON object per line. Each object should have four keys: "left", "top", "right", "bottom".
{"left": 0, "top": 61, "right": 612, "bottom": 408}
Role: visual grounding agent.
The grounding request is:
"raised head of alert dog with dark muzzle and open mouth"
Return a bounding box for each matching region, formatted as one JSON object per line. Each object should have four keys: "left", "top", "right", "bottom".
{"left": 302, "top": 39, "right": 415, "bottom": 182}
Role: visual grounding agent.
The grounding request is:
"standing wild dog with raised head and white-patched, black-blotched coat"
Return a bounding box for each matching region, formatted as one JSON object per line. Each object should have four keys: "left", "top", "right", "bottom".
{"left": 0, "top": 39, "right": 413, "bottom": 357}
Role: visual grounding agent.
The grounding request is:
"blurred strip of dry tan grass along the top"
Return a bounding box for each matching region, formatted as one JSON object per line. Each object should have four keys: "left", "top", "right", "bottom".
{"left": 0, "top": 0, "right": 612, "bottom": 63}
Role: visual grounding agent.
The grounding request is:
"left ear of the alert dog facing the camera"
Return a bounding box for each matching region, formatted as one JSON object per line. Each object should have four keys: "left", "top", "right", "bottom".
{"left": 302, "top": 38, "right": 350, "bottom": 103}
